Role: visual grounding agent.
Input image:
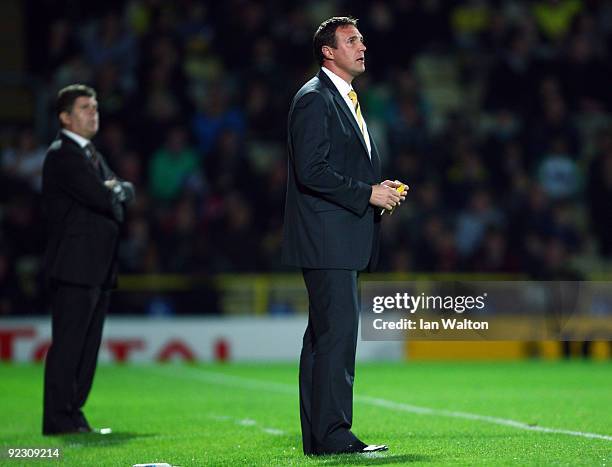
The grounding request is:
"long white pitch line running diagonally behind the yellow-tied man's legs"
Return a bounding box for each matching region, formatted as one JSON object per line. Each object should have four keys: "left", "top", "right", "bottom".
{"left": 147, "top": 366, "right": 612, "bottom": 441}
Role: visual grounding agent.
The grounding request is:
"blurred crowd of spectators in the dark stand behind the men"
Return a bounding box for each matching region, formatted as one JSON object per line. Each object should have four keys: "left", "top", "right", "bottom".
{"left": 0, "top": 0, "right": 612, "bottom": 314}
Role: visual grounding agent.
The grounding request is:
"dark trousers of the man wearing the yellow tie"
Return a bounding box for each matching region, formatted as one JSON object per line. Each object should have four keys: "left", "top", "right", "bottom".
{"left": 300, "top": 269, "right": 359, "bottom": 454}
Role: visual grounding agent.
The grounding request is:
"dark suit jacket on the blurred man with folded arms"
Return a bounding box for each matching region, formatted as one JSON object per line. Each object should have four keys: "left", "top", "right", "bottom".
{"left": 42, "top": 133, "right": 123, "bottom": 287}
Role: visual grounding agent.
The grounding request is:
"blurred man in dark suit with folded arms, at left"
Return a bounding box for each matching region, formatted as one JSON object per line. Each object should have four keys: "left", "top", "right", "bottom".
{"left": 43, "top": 84, "right": 134, "bottom": 435}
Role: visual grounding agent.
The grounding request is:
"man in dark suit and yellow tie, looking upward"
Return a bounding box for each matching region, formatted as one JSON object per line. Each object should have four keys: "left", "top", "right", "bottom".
{"left": 283, "top": 17, "right": 405, "bottom": 454}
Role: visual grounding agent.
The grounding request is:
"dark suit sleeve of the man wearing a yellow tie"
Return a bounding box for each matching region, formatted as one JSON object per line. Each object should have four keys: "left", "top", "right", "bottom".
{"left": 290, "top": 93, "right": 372, "bottom": 216}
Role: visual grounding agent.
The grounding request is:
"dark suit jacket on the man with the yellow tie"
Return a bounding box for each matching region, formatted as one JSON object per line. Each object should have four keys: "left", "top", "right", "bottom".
{"left": 282, "top": 70, "right": 381, "bottom": 271}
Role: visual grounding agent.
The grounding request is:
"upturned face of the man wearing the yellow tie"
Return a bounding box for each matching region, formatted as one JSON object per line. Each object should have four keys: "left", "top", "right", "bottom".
{"left": 328, "top": 25, "right": 366, "bottom": 82}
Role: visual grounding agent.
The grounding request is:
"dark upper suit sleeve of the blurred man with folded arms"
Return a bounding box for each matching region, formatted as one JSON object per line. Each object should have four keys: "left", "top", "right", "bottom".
{"left": 48, "top": 152, "right": 114, "bottom": 216}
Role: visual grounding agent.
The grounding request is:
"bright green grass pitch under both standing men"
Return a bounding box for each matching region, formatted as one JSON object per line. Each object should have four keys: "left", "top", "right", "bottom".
{"left": 0, "top": 361, "right": 612, "bottom": 466}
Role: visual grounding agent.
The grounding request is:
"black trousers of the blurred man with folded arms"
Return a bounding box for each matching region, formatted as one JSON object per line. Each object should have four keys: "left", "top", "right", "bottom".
{"left": 43, "top": 283, "right": 110, "bottom": 433}
